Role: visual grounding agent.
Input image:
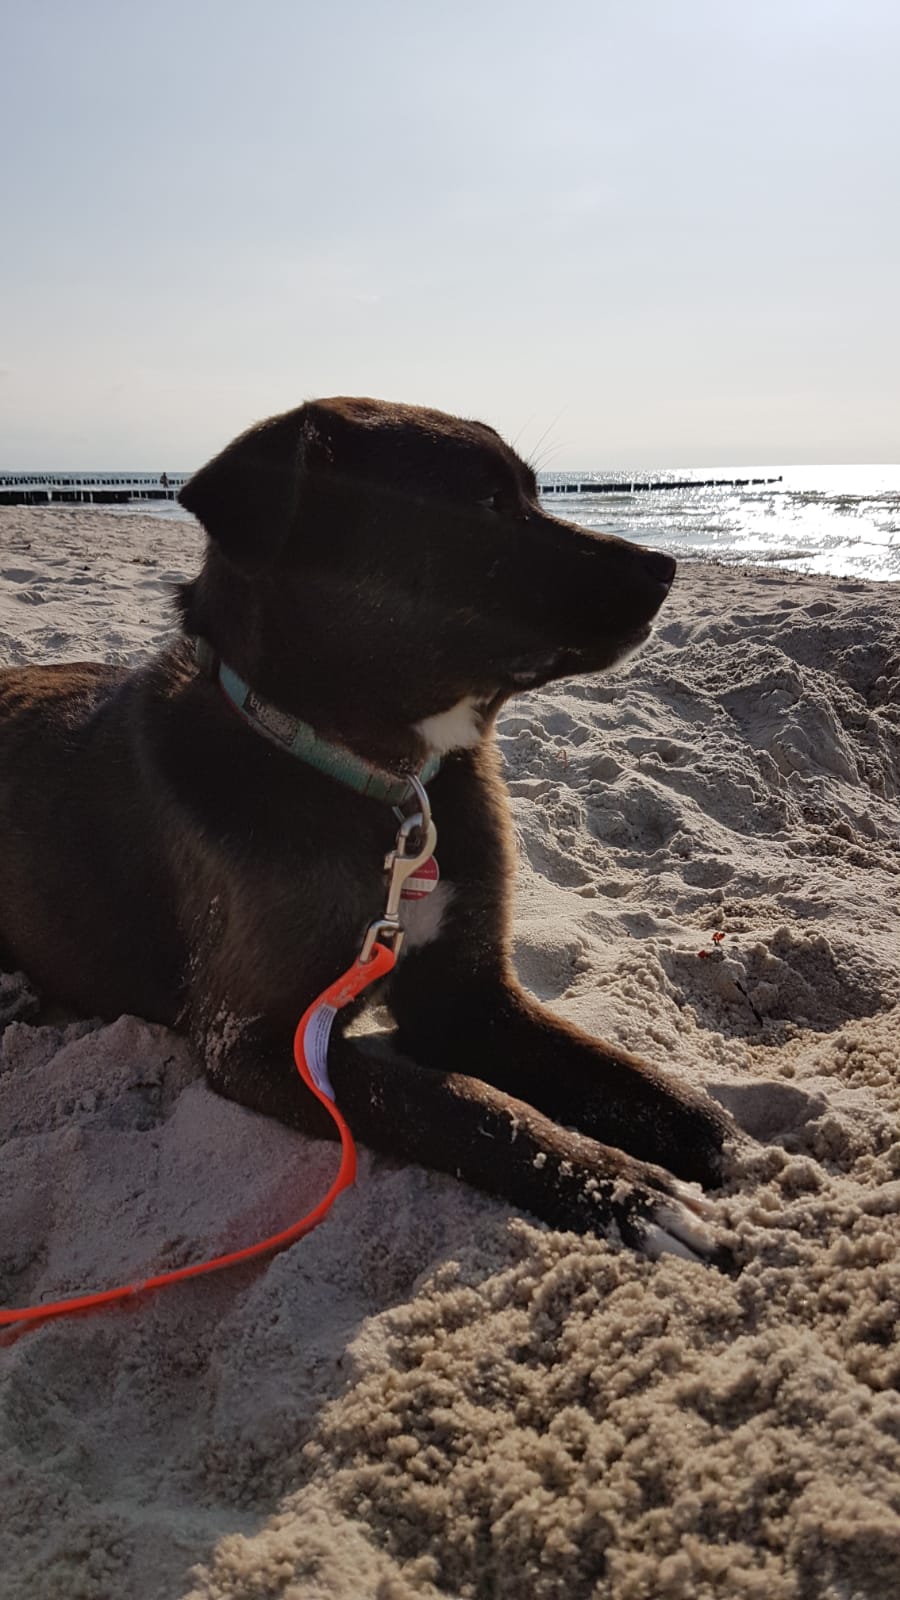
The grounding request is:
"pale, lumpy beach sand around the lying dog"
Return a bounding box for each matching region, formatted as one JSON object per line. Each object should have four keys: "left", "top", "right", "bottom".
{"left": 0, "top": 510, "right": 900, "bottom": 1600}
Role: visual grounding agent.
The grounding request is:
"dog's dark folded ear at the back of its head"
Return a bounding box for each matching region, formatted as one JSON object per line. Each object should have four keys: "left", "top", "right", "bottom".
{"left": 178, "top": 406, "right": 306, "bottom": 573}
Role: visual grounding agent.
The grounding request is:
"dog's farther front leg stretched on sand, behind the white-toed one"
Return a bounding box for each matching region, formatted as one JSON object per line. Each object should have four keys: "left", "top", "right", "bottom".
{"left": 391, "top": 939, "right": 738, "bottom": 1186}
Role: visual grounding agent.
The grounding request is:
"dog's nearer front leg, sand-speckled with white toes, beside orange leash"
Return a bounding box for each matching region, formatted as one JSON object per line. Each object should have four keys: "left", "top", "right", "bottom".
{"left": 207, "top": 1029, "right": 721, "bottom": 1261}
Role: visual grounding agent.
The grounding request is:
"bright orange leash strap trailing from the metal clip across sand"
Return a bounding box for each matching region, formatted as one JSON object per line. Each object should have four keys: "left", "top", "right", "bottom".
{"left": 0, "top": 942, "right": 397, "bottom": 1328}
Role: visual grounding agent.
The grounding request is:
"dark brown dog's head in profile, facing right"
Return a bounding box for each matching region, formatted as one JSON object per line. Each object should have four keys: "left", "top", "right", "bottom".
{"left": 179, "top": 398, "right": 674, "bottom": 764}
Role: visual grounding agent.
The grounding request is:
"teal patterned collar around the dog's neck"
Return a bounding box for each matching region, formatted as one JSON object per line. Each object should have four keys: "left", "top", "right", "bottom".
{"left": 192, "top": 638, "right": 440, "bottom": 805}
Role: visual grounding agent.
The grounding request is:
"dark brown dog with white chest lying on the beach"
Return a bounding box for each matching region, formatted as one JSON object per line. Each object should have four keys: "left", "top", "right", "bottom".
{"left": 0, "top": 400, "right": 733, "bottom": 1258}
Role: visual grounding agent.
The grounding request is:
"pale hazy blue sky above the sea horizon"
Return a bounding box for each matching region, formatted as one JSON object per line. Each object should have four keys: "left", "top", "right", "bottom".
{"left": 0, "top": 0, "right": 900, "bottom": 470}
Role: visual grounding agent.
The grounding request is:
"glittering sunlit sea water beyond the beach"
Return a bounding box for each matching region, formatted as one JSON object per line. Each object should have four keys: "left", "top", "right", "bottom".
{"left": 22, "top": 464, "right": 900, "bottom": 582}
